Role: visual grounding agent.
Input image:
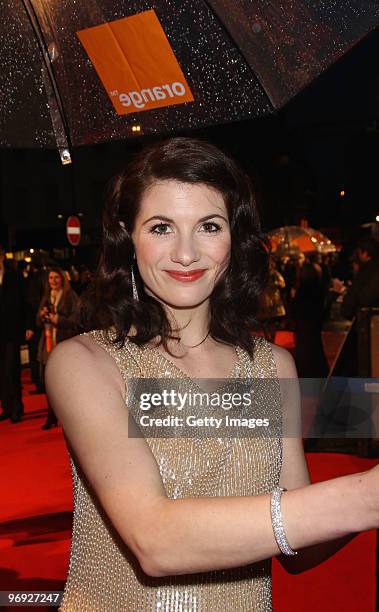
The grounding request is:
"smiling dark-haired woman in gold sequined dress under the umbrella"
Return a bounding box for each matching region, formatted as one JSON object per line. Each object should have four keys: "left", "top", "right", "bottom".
{"left": 46, "top": 138, "right": 379, "bottom": 612}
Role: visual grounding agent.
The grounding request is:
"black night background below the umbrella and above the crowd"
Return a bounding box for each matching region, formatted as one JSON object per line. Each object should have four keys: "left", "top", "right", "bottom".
{"left": 0, "top": 32, "right": 379, "bottom": 260}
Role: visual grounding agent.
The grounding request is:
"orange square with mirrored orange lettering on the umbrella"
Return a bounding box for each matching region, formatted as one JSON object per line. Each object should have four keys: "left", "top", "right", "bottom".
{"left": 77, "top": 10, "right": 194, "bottom": 115}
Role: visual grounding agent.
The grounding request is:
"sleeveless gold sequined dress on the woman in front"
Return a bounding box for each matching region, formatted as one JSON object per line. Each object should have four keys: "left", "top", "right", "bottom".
{"left": 59, "top": 331, "right": 282, "bottom": 612}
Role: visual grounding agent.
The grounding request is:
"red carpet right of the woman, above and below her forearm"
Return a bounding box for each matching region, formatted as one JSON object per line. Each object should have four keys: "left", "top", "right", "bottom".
{"left": 273, "top": 453, "right": 377, "bottom": 612}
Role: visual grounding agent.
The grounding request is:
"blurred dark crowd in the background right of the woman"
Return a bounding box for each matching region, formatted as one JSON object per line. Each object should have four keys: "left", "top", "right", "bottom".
{"left": 258, "top": 237, "right": 379, "bottom": 378}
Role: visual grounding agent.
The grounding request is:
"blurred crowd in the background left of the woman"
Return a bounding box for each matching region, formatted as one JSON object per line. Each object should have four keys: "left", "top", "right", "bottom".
{"left": 0, "top": 245, "right": 93, "bottom": 429}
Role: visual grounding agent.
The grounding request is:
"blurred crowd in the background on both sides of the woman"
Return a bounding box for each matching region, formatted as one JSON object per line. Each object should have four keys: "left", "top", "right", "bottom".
{"left": 0, "top": 237, "right": 379, "bottom": 429}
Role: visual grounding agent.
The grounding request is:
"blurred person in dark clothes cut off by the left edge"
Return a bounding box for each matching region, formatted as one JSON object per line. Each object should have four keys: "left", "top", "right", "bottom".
{"left": 0, "top": 245, "right": 33, "bottom": 423}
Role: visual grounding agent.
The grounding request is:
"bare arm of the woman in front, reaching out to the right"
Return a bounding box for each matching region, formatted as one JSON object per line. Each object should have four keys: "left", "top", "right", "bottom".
{"left": 46, "top": 337, "right": 379, "bottom": 576}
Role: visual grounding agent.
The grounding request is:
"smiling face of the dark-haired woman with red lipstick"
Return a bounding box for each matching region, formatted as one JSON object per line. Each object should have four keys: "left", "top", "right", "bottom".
{"left": 132, "top": 180, "right": 231, "bottom": 308}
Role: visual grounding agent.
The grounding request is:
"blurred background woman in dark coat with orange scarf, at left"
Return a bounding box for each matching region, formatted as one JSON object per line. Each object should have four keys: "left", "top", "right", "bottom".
{"left": 37, "top": 267, "right": 78, "bottom": 429}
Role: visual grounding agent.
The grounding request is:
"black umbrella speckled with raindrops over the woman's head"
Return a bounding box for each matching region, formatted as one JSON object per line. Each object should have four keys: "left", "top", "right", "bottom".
{"left": 0, "top": 0, "right": 379, "bottom": 162}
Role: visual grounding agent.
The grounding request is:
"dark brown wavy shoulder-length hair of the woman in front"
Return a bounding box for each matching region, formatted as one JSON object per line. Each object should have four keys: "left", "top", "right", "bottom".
{"left": 82, "top": 137, "right": 269, "bottom": 354}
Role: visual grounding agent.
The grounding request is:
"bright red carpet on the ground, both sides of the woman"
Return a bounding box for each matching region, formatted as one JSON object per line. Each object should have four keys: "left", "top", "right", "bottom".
{"left": 0, "top": 373, "right": 377, "bottom": 612}
